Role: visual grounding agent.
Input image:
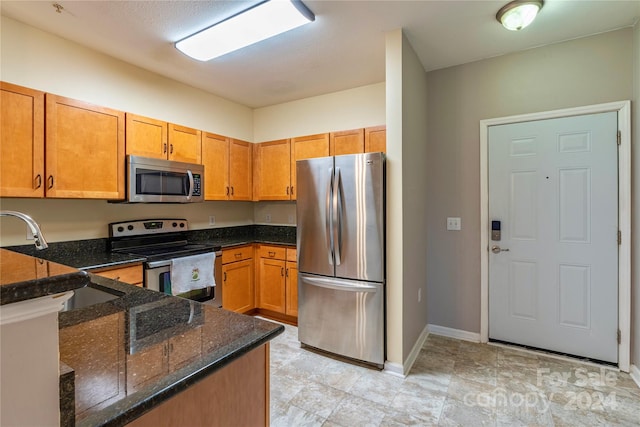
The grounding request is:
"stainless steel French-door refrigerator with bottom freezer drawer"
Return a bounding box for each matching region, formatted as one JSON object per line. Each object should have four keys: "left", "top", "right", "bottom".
{"left": 296, "top": 153, "right": 385, "bottom": 366}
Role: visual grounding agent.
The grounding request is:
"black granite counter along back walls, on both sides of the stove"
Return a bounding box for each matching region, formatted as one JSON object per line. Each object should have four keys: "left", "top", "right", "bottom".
{"left": 5, "top": 225, "right": 296, "bottom": 270}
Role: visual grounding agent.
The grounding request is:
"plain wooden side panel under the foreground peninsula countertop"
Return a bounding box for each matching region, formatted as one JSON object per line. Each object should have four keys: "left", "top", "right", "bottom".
{"left": 128, "top": 343, "right": 269, "bottom": 427}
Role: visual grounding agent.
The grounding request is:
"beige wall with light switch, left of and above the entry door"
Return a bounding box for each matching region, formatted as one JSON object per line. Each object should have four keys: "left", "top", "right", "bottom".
{"left": 426, "top": 29, "right": 640, "bottom": 333}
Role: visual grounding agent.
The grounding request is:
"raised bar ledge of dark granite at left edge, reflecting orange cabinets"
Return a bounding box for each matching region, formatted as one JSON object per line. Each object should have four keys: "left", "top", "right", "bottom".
{"left": 0, "top": 249, "right": 89, "bottom": 305}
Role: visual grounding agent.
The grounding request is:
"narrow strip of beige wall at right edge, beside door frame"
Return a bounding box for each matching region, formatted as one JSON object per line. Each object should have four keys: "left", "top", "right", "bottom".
{"left": 631, "top": 22, "right": 640, "bottom": 369}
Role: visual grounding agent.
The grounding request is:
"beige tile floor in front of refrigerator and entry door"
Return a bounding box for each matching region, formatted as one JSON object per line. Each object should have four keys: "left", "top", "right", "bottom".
{"left": 271, "top": 326, "right": 640, "bottom": 427}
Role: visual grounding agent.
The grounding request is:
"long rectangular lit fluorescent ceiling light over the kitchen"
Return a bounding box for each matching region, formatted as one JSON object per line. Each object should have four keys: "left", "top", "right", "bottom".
{"left": 176, "top": 0, "right": 316, "bottom": 61}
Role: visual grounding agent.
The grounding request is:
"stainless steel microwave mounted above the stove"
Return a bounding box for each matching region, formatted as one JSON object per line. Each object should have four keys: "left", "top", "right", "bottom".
{"left": 127, "top": 155, "right": 204, "bottom": 203}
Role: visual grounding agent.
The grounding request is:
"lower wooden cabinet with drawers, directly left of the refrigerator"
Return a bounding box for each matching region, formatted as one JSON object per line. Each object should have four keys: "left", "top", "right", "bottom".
{"left": 256, "top": 245, "right": 298, "bottom": 323}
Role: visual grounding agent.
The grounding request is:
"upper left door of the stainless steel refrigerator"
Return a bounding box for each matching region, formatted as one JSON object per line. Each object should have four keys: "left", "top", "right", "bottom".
{"left": 296, "top": 157, "right": 335, "bottom": 276}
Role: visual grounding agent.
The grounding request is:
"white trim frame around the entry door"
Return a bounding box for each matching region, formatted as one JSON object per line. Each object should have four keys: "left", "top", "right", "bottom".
{"left": 480, "top": 101, "right": 631, "bottom": 372}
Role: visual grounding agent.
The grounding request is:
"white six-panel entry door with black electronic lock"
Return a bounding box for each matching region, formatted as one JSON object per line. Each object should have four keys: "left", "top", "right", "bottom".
{"left": 488, "top": 112, "right": 618, "bottom": 363}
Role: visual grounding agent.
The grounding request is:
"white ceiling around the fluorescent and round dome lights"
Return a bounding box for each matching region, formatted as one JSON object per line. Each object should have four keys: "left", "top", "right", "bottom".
{"left": 0, "top": 0, "right": 640, "bottom": 108}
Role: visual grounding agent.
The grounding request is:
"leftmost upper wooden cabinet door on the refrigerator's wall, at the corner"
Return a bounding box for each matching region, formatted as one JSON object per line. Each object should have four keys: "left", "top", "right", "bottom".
{"left": 253, "top": 139, "right": 291, "bottom": 200}
